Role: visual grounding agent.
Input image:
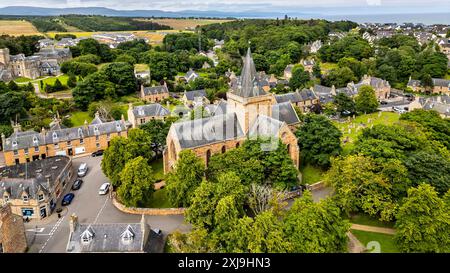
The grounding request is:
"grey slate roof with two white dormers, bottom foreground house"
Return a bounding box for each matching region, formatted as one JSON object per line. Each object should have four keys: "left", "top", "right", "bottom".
{"left": 66, "top": 223, "right": 153, "bottom": 253}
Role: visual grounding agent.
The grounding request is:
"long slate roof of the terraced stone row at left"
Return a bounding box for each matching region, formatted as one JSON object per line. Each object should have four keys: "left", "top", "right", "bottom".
{"left": 3, "top": 120, "right": 127, "bottom": 151}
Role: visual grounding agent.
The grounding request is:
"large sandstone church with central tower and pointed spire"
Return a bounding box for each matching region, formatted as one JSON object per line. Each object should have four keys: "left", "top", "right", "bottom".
{"left": 163, "top": 49, "right": 299, "bottom": 173}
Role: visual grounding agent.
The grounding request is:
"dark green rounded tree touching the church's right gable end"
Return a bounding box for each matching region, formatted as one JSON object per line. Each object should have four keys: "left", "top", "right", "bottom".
{"left": 295, "top": 115, "right": 342, "bottom": 167}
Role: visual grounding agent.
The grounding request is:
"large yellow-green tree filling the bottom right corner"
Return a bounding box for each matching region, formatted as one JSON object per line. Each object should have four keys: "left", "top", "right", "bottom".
{"left": 395, "top": 184, "right": 450, "bottom": 253}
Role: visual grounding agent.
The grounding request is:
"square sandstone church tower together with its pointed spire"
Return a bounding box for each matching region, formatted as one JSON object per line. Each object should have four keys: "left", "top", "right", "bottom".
{"left": 227, "top": 48, "right": 275, "bottom": 132}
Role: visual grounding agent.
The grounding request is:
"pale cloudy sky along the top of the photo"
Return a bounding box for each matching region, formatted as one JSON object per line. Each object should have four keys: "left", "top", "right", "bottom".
{"left": 0, "top": 0, "right": 450, "bottom": 16}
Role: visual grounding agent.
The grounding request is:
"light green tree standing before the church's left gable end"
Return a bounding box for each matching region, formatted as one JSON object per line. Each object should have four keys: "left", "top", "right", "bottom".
{"left": 166, "top": 150, "right": 205, "bottom": 207}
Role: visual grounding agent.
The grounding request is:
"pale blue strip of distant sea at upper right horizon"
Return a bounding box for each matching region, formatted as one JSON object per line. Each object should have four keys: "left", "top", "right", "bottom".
{"left": 299, "top": 13, "right": 450, "bottom": 25}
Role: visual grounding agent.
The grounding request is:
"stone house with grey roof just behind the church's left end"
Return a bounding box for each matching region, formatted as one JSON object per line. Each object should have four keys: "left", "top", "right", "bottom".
{"left": 128, "top": 103, "right": 170, "bottom": 128}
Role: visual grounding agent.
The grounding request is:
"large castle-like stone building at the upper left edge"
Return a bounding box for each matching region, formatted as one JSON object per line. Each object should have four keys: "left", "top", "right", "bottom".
{"left": 0, "top": 48, "right": 72, "bottom": 81}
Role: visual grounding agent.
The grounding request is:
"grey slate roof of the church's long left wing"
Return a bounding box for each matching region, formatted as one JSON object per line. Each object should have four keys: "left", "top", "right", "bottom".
{"left": 172, "top": 113, "right": 244, "bottom": 149}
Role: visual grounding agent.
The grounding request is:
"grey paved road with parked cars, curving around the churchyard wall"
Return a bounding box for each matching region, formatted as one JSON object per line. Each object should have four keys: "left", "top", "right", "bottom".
{"left": 26, "top": 157, "right": 190, "bottom": 253}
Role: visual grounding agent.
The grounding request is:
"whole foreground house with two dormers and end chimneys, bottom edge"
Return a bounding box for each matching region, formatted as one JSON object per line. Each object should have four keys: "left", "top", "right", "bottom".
{"left": 66, "top": 214, "right": 163, "bottom": 253}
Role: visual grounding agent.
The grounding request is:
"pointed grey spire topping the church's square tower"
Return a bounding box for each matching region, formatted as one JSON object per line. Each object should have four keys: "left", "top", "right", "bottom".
{"left": 234, "top": 47, "right": 267, "bottom": 98}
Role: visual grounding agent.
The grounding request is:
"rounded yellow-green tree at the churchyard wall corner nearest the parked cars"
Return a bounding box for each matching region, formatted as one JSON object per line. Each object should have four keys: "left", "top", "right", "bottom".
{"left": 117, "top": 156, "right": 155, "bottom": 207}
